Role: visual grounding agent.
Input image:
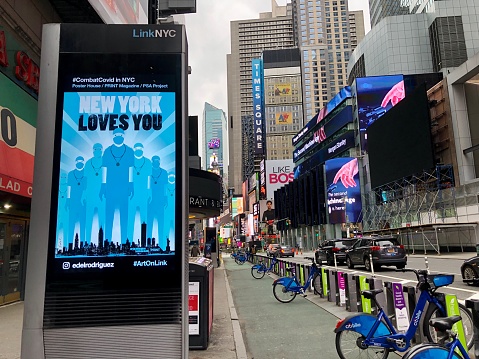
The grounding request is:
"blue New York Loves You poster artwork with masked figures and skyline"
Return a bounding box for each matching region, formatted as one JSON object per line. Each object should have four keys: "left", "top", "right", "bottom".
{"left": 55, "top": 92, "right": 175, "bottom": 257}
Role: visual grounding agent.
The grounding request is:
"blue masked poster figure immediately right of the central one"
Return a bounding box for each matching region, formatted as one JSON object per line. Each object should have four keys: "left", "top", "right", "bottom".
{"left": 128, "top": 143, "right": 151, "bottom": 243}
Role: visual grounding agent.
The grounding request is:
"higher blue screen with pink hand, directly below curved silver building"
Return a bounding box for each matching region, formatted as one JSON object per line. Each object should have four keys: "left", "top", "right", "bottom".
{"left": 356, "top": 75, "right": 406, "bottom": 152}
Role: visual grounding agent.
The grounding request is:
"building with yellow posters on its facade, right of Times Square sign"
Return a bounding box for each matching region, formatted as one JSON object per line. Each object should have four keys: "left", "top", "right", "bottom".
{"left": 263, "top": 47, "right": 303, "bottom": 160}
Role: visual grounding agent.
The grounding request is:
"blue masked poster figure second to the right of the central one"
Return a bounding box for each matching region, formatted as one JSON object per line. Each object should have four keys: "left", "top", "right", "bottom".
{"left": 147, "top": 156, "right": 168, "bottom": 248}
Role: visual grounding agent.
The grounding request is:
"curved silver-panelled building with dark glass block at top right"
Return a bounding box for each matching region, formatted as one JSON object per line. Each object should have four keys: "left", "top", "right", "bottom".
{"left": 348, "top": 0, "right": 479, "bottom": 84}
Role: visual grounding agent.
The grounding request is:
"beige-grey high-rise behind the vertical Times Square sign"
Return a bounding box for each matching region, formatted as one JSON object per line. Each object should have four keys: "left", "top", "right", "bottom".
{"left": 227, "top": 0, "right": 294, "bottom": 193}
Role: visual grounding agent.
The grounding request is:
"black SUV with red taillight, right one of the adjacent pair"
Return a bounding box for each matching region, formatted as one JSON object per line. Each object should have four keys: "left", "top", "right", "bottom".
{"left": 346, "top": 236, "right": 407, "bottom": 270}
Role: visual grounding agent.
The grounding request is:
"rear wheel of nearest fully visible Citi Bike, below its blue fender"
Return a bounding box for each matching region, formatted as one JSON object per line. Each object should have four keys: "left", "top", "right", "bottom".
{"left": 336, "top": 330, "right": 389, "bottom": 359}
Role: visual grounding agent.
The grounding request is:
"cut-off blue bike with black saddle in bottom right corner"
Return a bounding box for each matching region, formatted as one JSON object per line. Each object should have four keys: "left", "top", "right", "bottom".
{"left": 403, "top": 315, "right": 469, "bottom": 359}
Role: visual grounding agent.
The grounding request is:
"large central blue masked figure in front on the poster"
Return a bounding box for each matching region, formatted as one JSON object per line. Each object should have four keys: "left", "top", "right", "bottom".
{"left": 100, "top": 128, "right": 134, "bottom": 244}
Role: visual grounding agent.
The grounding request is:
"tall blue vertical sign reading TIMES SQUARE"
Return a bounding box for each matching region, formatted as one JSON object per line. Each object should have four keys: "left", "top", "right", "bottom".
{"left": 252, "top": 59, "right": 266, "bottom": 156}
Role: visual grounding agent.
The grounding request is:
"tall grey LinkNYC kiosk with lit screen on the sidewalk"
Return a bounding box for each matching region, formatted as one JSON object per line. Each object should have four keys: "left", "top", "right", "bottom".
{"left": 22, "top": 24, "right": 188, "bottom": 359}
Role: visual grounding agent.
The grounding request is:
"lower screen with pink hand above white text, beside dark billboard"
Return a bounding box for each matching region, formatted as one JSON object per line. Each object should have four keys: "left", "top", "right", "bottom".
{"left": 325, "top": 157, "right": 361, "bottom": 224}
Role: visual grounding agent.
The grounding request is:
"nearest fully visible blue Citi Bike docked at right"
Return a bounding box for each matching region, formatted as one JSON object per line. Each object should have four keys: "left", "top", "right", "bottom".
{"left": 334, "top": 269, "right": 473, "bottom": 359}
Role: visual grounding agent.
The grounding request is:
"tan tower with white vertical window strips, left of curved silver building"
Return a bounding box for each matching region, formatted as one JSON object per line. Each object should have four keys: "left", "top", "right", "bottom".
{"left": 292, "top": 0, "right": 364, "bottom": 119}
